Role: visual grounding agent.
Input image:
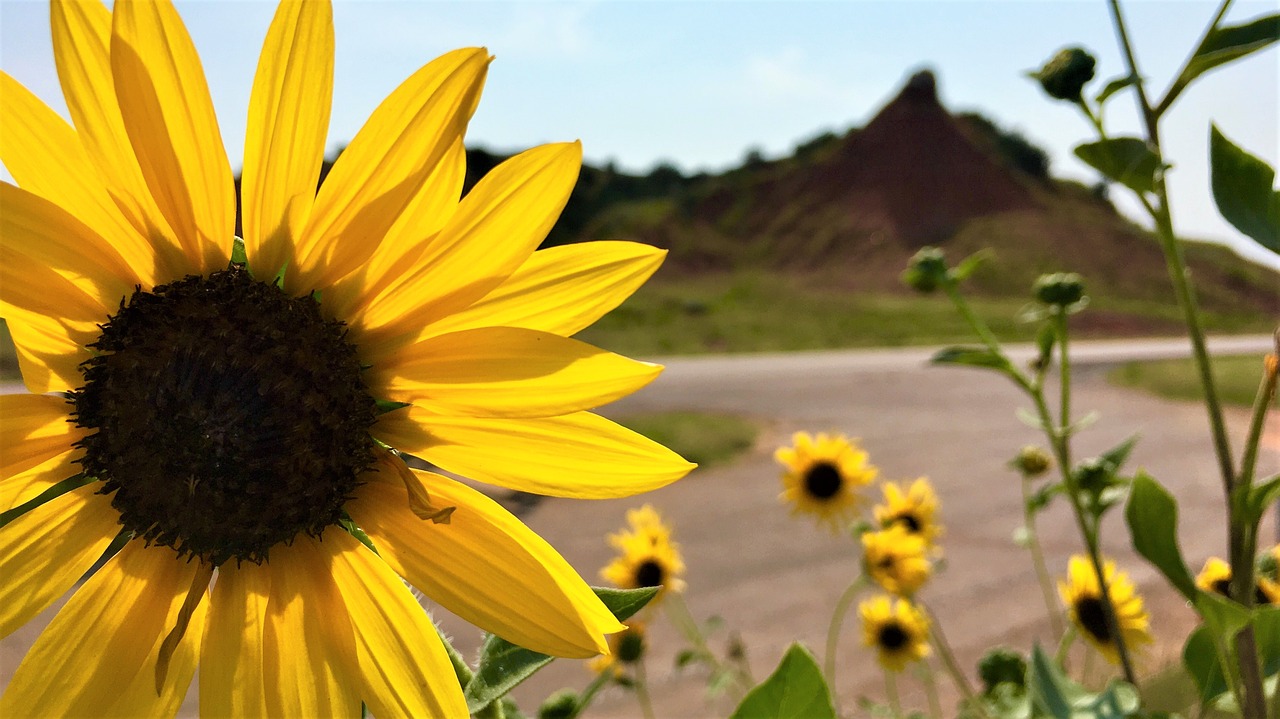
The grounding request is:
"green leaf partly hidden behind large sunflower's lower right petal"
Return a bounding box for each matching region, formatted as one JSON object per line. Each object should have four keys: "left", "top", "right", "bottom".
{"left": 462, "top": 587, "right": 658, "bottom": 714}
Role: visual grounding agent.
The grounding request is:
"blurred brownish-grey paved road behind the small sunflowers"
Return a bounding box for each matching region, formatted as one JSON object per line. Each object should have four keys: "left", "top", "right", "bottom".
{"left": 0, "top": 336, "right": 1280, "bottom": 718}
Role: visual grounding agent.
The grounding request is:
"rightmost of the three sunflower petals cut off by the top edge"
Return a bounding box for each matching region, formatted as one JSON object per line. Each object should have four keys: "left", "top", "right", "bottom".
{"left": 241, "top": 0, "right": 333, "bottom": 279}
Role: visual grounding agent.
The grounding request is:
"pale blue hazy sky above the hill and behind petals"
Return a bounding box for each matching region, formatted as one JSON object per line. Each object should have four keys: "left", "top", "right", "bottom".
{"left": 0, "top": 0, "right": 1280, "bottom": 270}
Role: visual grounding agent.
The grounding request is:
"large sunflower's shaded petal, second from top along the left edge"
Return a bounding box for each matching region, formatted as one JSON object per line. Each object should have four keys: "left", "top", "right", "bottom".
{"left": 0, "top": 183, "right": 136, "bottom": 307}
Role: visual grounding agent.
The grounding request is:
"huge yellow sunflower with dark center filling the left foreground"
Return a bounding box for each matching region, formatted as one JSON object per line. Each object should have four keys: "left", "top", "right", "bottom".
{"left": 0, "top": 0, "right": 691, "bottom": 716}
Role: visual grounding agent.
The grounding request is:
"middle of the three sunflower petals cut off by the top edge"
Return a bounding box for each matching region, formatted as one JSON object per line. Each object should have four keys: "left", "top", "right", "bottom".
{"left": 111, "top": 0, "right": 236, "bottom": 274}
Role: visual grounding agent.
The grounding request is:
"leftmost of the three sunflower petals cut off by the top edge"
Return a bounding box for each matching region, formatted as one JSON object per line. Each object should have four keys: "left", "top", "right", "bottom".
{"left": 50, "top": 0, "right": 191, "bottom": 269}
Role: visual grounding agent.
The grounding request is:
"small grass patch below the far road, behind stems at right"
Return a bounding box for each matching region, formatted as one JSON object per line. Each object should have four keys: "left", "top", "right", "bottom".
{"left": 1107, "top": 354, "right": 1262, "bottom": 407}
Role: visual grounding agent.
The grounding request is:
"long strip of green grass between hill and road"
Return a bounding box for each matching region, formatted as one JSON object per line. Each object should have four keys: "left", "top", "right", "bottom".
{"left": 579, "top": 273, "right": 1268, "bottom": 356}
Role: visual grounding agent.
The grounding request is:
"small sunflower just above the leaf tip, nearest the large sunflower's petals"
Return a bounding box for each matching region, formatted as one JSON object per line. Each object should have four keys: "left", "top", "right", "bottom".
{"left": 600, "top": 504, "right": 685, "bottom": 605}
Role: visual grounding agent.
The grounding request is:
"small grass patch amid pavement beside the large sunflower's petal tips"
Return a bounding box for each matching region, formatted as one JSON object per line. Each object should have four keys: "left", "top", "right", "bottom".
{"left": 618, "top": 412, "right": 756, "bottom": 467}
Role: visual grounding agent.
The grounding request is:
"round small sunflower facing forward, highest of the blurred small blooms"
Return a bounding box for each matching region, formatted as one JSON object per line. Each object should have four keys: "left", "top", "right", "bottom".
{"left": 773, "top": 432, "right": 877, "bottom": 531}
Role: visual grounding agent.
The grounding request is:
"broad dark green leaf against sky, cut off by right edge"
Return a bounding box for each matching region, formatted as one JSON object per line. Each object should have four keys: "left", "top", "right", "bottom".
{"left": 1208, "top": 127, "right": 1280, "bottom": 253}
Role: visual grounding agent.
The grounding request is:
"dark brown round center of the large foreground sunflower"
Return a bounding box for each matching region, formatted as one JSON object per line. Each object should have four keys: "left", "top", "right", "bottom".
{"left": 70, "top": 266, "right": 376, "bottom": 565}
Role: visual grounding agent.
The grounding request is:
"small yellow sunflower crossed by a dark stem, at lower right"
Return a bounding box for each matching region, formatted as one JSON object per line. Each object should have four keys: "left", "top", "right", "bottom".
{"left": 1057, "top": 554, "right": 1152, "bottom": 664}
